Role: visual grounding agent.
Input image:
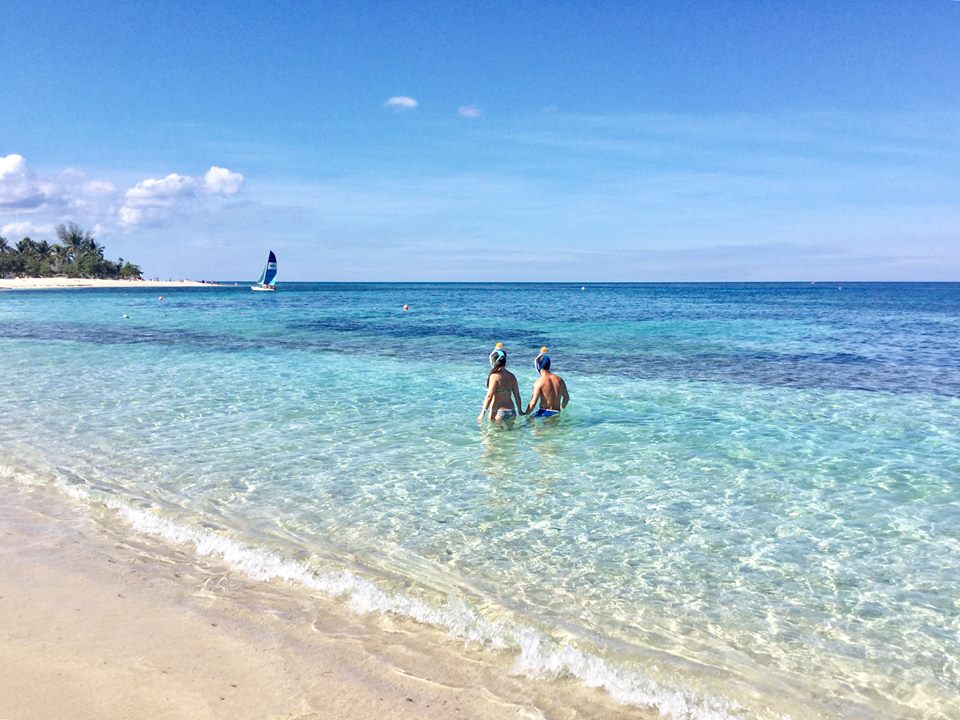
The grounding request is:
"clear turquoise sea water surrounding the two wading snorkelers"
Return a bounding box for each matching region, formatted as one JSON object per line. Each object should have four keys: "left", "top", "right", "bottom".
{"left": 0, "top": 284, "right": 960, "bottom": 718}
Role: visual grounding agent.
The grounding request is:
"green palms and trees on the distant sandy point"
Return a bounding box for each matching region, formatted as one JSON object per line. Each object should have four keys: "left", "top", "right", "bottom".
{"left": 0, "top": 223, "right": 143, "bottom": 280}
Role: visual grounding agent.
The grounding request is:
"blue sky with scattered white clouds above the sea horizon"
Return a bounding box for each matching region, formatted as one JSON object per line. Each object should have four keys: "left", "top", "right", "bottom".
{"left": 0, "top": 0, "right": 960, "bottom": 282}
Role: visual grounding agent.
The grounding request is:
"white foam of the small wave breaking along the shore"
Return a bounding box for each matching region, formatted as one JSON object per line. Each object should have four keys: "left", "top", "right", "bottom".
{"left": 0, "top": 465, "right": 750, "bottom": 720}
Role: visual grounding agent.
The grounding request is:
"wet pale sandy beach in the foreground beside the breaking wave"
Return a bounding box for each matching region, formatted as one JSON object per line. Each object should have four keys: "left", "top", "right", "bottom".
{"left": 0, "top": 483, "right": 651, "bottom": 720}
